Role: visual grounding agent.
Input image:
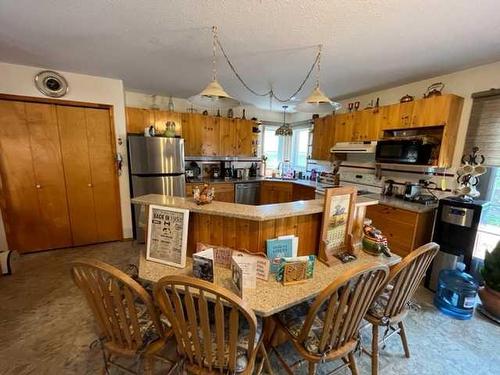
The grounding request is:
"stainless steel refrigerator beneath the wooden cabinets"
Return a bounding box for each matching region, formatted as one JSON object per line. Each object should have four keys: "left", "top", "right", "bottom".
{"left": 128, "top": 134, "right": 186, "bottom": 242}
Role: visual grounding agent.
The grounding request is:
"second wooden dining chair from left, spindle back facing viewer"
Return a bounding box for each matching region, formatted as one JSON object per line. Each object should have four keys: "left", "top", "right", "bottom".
{"left": 154, "top": 275, "right": 272, "bottom": 375}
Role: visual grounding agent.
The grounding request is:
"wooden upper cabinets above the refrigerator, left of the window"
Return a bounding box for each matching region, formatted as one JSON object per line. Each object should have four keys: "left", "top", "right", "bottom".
{"left": 126, "top": 107, "right": 258, "bottom": 157}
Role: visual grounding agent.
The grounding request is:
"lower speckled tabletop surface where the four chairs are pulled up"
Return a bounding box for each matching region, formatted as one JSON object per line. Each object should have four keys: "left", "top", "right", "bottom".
{"left": 139, "top": 250, "right": 401, "bottom": 317}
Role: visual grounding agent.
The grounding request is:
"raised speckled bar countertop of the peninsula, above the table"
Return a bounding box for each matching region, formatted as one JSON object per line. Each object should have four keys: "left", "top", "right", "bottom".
{"left": 132, "top": 194, "right": 378, "bottom": 221}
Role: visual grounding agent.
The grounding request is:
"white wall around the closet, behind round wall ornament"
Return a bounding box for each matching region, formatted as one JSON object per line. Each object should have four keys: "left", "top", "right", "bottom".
{"left": 0, "top": 62, "right": 132, "bottom": 249}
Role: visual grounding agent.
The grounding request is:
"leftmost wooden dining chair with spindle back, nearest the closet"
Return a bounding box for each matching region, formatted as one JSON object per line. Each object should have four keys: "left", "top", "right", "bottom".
{"left": 71, "top": 259, "right": 176, "bottom": 374}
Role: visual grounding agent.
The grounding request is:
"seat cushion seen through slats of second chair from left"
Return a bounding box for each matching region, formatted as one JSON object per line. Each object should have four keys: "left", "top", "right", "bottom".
{"left": 186, "top": 316, "right": 263, "bottom": 373}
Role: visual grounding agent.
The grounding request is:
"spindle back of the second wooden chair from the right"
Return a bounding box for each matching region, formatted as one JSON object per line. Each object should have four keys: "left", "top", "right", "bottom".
{"left": 297, "top": 264, "right": 389, "bottom": 356}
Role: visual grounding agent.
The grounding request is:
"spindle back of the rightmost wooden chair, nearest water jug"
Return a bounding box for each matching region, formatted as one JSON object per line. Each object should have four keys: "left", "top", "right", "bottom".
{"left": 380, "top": 242, "right": 439, "bottom": 318}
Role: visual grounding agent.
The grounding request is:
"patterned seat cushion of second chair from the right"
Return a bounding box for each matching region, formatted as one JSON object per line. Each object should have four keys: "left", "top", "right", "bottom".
{"left": 277, "top": 301, "right": 324, "bottom": 354}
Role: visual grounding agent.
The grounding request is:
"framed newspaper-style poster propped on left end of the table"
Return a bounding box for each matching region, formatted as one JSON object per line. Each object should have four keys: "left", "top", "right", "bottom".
{"left": 146, "top": 205, "right": 189, "bottom": 268}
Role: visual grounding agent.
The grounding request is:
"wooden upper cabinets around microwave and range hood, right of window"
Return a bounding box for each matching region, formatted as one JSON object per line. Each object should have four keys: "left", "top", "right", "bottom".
{"left": 311, "top": 94, "right": 463, "bottom": 167}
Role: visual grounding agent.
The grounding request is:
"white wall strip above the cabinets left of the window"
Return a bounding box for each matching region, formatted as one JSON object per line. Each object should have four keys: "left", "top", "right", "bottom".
{"left": 125, "top": 91, "right": 283, "bottom": 122}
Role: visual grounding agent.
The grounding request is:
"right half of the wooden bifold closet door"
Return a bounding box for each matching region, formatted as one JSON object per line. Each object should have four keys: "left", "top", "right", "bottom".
{"left": 57, "top": 106, "right": 121, "bottom": 245}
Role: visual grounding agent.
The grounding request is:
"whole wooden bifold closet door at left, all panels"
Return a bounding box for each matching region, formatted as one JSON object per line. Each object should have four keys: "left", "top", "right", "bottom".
{"left": 0, "top": 100, "right": 122, "bottom": 252}
